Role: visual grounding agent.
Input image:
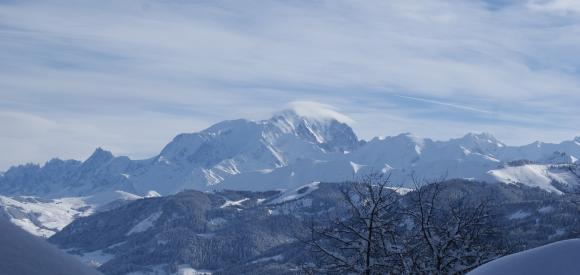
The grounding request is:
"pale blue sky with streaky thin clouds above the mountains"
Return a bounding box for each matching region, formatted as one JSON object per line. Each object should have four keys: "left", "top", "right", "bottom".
{"left": 0, "top": 0, "right": 580, "bottom": 170}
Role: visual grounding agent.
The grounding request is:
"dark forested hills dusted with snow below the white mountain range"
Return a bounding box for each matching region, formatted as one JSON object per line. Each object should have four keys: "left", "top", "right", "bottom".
{"left": 49, "top": 180, "right": 580, "bottom": 275}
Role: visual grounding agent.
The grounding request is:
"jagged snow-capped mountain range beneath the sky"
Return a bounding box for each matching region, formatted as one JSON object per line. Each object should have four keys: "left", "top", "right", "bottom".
{"left": 0, "top": 110, "right": 580, "bottom": 198}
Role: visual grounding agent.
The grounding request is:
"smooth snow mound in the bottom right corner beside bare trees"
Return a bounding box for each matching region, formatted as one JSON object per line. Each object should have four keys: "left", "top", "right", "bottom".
{"left": 469, "top": 239, "right": 580, "bottom": 275}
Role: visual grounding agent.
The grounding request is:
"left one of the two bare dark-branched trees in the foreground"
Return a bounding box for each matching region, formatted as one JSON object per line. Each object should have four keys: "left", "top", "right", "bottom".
{"left": 308, "top": 173, "right": 400, "bottom": 275}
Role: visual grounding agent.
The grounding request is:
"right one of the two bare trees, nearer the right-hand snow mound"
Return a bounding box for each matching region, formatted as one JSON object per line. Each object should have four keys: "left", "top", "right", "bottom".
{"left": 401, "top": 181, "right": 502, "bottom": 274}
